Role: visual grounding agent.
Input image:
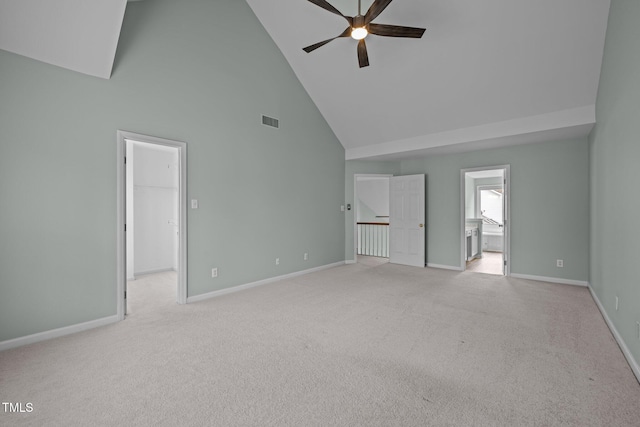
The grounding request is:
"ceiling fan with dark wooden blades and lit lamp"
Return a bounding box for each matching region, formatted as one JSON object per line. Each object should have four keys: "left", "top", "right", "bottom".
{"left": 302, "top": 0, "right": 425, "bottom": 68}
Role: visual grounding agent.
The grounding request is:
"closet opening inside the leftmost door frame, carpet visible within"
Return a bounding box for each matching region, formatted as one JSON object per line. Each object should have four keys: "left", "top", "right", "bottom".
{"left": 125, "top": 139, "right": 180, "bottom": 313}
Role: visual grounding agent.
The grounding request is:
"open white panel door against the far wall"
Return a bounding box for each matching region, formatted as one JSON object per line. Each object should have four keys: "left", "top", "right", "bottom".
{"left": 389, "top": 174, "right": 426, "bottom": 267}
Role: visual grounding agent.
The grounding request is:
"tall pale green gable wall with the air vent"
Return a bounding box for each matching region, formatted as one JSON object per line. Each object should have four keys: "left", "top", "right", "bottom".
{"left": 0, "top": 0, "right": 345, "bottom": 341}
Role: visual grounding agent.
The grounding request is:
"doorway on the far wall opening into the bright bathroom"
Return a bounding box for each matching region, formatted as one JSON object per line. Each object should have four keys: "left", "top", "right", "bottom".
{"left": 461, "top": 165, "right": 509, "bottom": 275}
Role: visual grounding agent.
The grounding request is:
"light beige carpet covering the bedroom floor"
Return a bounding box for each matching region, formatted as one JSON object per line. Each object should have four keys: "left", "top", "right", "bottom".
{"left": 0, "top": 263, "right": 640, "bottom": 426}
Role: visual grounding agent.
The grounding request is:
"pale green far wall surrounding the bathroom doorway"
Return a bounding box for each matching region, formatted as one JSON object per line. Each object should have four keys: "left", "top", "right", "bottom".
{"left": 401, "top": 138, "right": 589, "bottom": 281}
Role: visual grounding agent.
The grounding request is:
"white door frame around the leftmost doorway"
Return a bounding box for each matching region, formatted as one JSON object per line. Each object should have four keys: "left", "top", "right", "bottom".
{"left": 116, "top": 130, "right": 187, "bottom": 320}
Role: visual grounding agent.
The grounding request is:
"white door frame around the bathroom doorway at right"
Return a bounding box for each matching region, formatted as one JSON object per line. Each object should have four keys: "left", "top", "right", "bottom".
{"left": 459, "top": 165, "right": 511, "bottom": 276}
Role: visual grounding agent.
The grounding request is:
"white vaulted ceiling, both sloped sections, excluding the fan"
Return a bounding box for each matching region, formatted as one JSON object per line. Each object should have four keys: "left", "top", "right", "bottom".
{"left": 0, "top": 0, "right": 610, "bottom": 159}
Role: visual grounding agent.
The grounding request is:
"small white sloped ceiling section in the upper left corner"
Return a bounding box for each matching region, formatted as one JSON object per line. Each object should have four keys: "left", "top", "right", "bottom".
{"left": 0, "top": 0, "right": 127, "bottom": 79}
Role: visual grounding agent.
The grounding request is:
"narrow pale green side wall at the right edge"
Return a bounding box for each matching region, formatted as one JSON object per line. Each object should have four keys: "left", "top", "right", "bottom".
{"left": 590, "top": 0, "right": 640, "bottom": 368}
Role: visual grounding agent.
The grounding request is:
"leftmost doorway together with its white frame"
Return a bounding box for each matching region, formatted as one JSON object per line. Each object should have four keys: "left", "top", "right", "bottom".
{"left": 116, "top": 131, "right": 187, "bottom": 319}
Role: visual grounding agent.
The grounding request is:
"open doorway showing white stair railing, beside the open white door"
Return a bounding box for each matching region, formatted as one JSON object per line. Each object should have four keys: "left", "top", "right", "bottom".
{"left": 354, "top": 174, "right": 391, "bottom": 265}
